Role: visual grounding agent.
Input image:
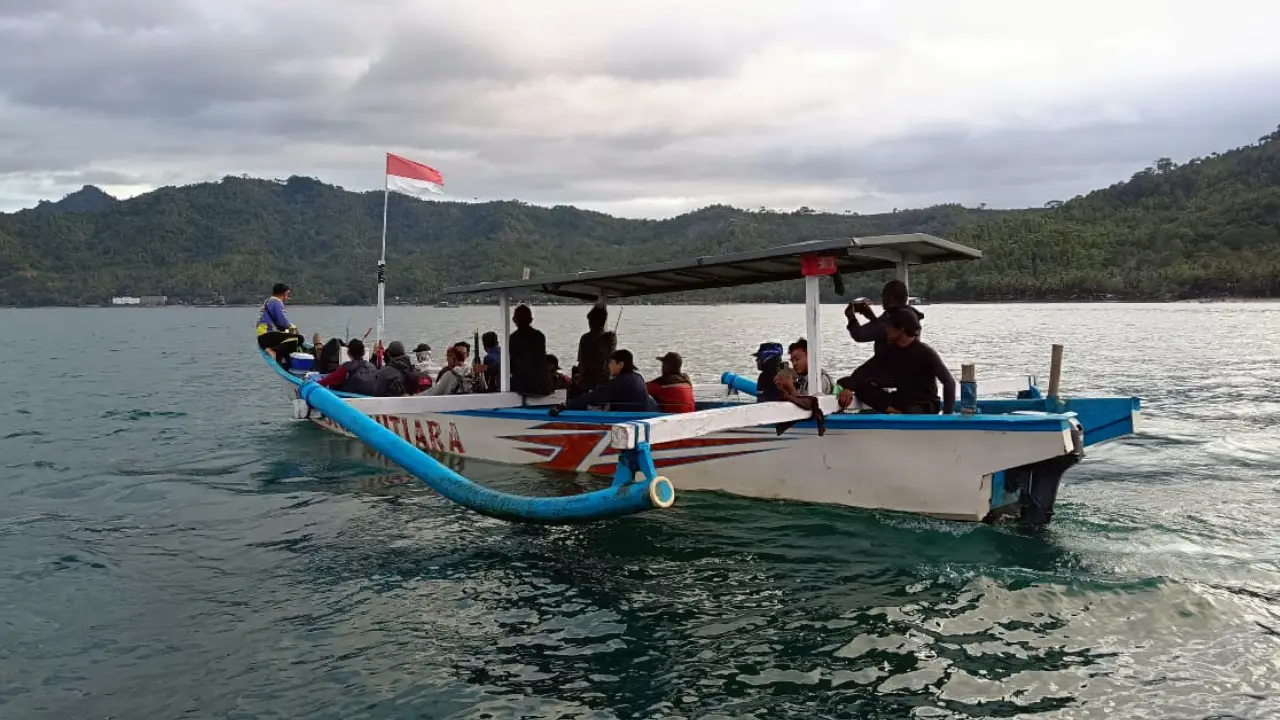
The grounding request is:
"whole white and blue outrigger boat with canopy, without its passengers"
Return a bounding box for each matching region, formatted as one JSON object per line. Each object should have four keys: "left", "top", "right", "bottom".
{"left": 264, "top": 234, "right": 1140, "bottom": 525}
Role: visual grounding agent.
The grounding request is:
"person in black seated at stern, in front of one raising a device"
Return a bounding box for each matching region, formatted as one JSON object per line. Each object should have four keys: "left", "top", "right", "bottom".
{"left": 840, "top": 307, "right": 956, "bottom": 415}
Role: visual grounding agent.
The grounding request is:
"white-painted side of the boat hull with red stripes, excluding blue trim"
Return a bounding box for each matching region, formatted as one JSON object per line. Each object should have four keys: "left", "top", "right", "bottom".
{"left": 296, "top": 397, "right": 1078, "bottom": 521}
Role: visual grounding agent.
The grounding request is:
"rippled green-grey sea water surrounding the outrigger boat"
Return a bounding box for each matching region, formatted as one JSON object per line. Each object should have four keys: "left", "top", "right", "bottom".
{"left": 0, "top": 304, "right": 1280, "bottom": 720}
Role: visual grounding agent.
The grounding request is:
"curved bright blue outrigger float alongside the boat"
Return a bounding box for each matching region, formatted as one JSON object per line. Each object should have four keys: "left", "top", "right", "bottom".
{"left": 298, "top": 380, "right": 676, "bottom": 524}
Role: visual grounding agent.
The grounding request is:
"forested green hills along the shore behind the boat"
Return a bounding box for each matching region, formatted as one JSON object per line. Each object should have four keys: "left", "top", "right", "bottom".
{"left": 0, "top": 129, "right": 1280, "bottom": 305}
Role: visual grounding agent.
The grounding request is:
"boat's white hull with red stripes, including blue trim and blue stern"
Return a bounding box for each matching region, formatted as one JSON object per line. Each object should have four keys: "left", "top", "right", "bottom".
{"left": 267, "top": 351, "right": 1139, "bottom": 524}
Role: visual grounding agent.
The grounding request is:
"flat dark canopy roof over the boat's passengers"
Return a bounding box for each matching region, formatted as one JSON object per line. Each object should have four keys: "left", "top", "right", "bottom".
{"left": 443, "top": 233, "right": 982, "bottom": 300}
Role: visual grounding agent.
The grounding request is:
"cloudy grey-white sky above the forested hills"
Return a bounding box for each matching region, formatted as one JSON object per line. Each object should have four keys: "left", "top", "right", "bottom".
{"left": 0, "top": 0, "right": 1280, "bottom": 217}
